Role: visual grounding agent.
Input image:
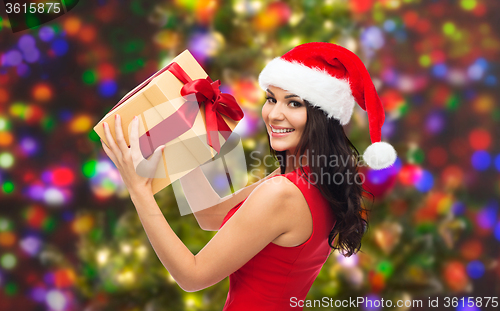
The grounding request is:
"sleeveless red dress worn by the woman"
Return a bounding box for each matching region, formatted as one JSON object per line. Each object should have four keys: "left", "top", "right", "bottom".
{"left": 221, "top": 166, "right": 335, "bottom": 311}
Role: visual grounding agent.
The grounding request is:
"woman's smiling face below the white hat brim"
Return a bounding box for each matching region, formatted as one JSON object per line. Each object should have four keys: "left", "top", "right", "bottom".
{"left": 262, "top": 85, "right": 307, "bottom": 154}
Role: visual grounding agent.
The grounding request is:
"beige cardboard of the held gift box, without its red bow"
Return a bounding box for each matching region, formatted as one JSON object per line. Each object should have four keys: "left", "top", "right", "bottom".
{"left": 94, "top": 50, "right": 243, "bottom": 194}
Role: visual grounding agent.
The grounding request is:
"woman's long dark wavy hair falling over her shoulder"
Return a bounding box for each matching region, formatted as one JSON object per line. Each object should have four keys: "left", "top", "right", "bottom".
{"left": 268, "top": 101, "right": 373, "bottom": 257}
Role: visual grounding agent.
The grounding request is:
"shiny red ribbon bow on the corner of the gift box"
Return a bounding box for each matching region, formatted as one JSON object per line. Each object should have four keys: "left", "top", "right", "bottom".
{"left": 168, "top": 63, "right": 243, "bottom": 153}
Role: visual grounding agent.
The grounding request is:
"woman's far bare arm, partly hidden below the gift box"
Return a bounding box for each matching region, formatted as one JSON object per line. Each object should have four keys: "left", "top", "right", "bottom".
{"left": 180, "top": 167, "right": 280, "bottom": 231}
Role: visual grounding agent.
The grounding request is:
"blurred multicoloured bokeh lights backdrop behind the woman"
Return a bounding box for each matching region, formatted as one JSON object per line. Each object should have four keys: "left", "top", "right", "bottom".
{"left": 0, "top": 0, "right": 500, "bottom": 311}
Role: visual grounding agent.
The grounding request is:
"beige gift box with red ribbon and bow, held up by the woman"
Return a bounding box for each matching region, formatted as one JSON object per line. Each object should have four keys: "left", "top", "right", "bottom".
{"left": 94, "top": 50, "right": 243, "bottom": 193}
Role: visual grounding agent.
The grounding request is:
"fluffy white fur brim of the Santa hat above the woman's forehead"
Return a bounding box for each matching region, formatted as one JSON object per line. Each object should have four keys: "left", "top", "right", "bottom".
{"left": 259, "top": 57, "right": 356, "bottom": 125}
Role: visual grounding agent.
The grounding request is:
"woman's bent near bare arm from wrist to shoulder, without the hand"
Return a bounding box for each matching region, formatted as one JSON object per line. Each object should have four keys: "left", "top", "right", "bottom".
{"left": 131, "top": 176, "right": 307, "bottom": 291}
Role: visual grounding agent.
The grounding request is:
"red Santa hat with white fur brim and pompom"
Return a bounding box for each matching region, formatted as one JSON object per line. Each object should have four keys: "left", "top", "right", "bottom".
{"left": 259, "top": 42, "right": 397, "bottom": 169}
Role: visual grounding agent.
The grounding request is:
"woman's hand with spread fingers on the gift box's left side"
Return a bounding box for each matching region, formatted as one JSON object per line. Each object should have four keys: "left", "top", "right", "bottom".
{"left": 101, "top": 114, "right": 165, "bottom": 194}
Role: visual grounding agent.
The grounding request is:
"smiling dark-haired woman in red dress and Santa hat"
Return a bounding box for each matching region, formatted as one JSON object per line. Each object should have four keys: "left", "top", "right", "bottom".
{"left": 103, "top": 42, "right": 396, "bottom": 310}
